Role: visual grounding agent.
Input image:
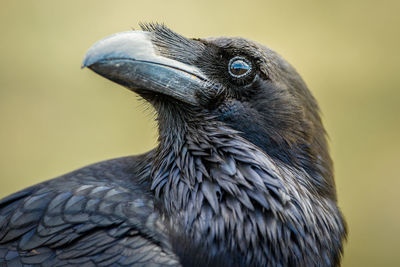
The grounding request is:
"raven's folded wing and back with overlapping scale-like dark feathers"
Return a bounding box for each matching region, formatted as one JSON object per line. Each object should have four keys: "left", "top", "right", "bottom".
{"left": 0, "top": 157, "right": 177, "bottom": 266}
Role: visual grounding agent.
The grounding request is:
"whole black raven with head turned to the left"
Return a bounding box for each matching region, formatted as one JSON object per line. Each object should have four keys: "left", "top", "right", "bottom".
{"left": 0, "top": 24, "right": 346, "bottom": 266}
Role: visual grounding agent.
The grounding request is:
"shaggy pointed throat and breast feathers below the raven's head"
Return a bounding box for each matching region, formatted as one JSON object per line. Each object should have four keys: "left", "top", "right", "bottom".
{"left": 151, "top": 101, "right": 343, "bottom": 266}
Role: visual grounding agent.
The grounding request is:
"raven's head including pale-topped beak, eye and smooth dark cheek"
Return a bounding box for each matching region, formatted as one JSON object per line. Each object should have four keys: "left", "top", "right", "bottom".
{"left": 83, "top": 24, "right": 335, "bottom": 199}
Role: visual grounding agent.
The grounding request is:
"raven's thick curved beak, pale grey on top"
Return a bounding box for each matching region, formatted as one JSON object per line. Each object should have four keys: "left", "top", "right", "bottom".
{"left": 82, "top": 31, "right": 209, "bottom": 104}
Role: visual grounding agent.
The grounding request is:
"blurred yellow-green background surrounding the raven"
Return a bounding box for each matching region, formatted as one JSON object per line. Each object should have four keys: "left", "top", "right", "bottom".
{"left": 0, "top": 0, "right": 400, "bottom": 266}
